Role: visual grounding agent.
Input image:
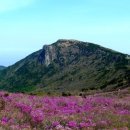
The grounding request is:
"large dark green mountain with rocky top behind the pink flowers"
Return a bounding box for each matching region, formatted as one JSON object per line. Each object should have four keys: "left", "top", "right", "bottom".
{"left": 0, "top": 39, "right": 130, "bottom": 93}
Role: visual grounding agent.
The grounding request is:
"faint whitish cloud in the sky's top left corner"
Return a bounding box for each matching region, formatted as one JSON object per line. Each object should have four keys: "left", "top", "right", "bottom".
{"left": 0, "top": 0, "right": 35, "bottom": 12}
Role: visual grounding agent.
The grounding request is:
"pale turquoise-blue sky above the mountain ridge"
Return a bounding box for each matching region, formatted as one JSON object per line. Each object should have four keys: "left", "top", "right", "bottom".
{"left": 0, "top": 0, "right": 130, "bottom": 66}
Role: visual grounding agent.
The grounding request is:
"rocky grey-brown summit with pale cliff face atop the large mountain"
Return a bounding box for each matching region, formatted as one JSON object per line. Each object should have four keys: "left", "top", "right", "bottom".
{"left": 39, "top": 39, "right": 98, "bottom": 66}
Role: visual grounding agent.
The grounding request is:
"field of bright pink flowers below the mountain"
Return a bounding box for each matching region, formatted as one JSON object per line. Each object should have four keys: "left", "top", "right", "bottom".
{"left": 0, "top": 92, "right": 130, "bottom": 130}
